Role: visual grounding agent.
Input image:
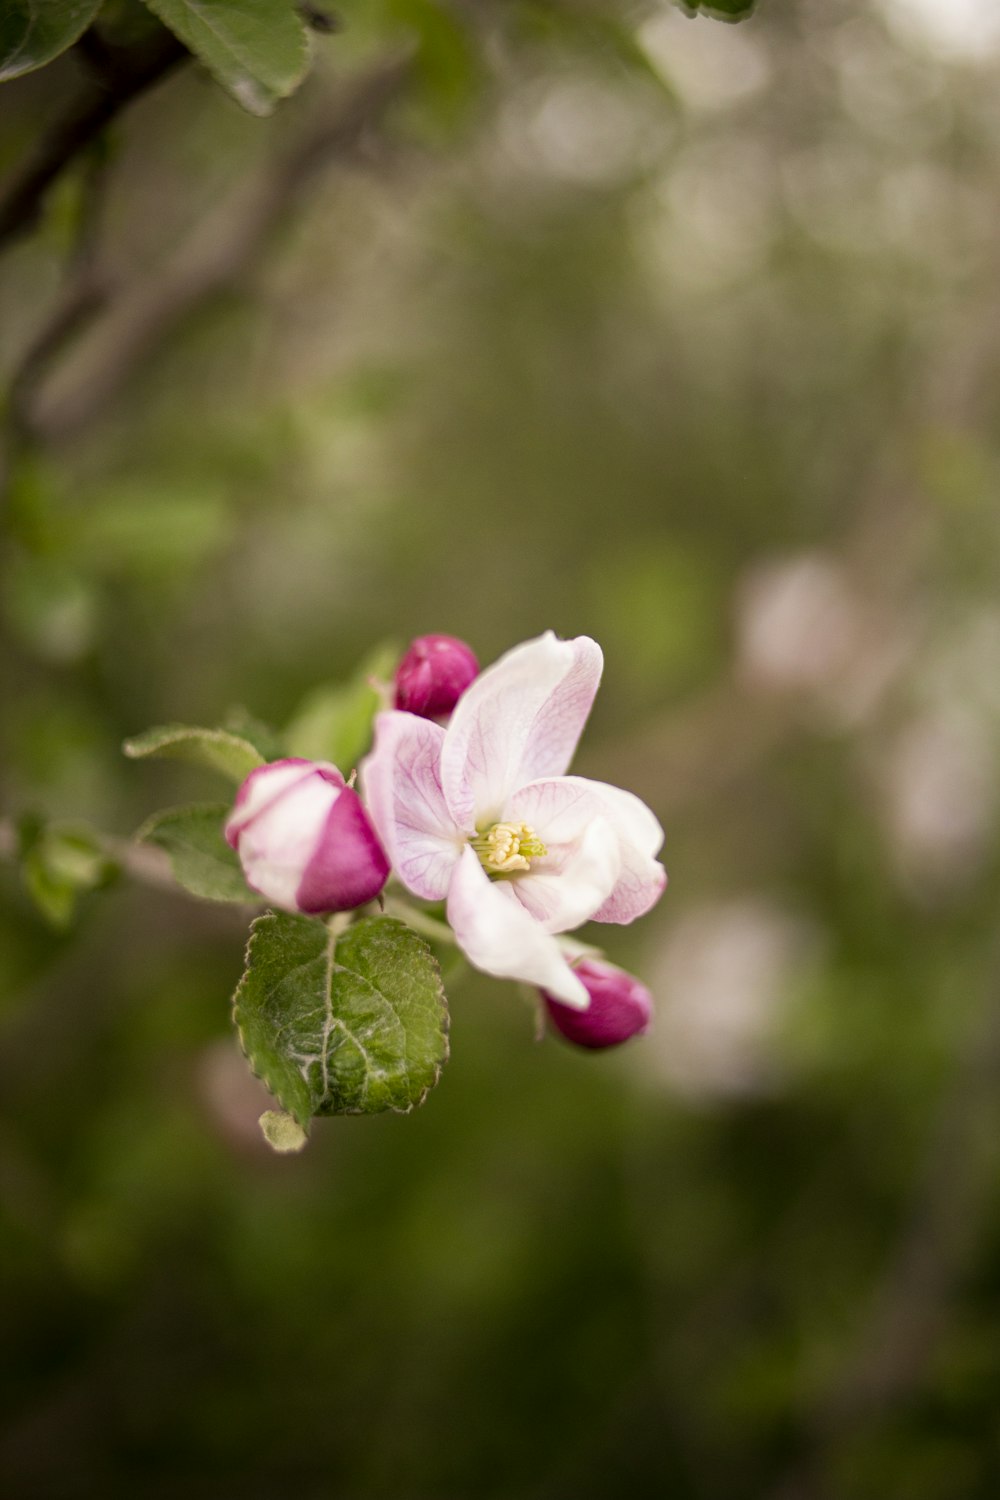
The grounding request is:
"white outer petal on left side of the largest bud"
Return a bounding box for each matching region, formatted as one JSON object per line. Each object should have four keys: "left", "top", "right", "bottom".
{"left": 238, "top": 774, "right": 340, "bottom": 912}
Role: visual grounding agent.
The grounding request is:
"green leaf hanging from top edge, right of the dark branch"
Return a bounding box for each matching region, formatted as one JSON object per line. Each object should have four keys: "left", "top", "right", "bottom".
{"left": 137, "top": 0, "right": 309, "bottom": 114}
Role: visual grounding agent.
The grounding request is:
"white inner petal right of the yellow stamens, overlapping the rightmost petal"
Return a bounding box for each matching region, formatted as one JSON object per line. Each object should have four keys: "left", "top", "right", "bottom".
{"left": 505, "top": 776, "right": 622, "bottom": 933}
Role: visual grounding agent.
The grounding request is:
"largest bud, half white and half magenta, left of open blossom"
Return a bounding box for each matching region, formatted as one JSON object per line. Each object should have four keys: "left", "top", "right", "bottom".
{"left": 225, "top": 759, "right": 388, "bottom": 915}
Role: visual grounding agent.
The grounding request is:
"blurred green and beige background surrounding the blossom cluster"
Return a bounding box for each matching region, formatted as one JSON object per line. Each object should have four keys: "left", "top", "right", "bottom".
{"left": 0, "top": 0, "right": 1000, "bottom": 1500}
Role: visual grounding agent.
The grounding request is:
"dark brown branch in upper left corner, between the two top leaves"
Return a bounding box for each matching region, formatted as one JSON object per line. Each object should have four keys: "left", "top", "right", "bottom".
{"left": 0, "top": 29, "right": 189, "bottom": 252}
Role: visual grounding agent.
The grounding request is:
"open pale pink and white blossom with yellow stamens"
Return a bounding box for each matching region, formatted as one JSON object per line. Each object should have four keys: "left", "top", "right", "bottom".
{"left": 363, "top": 632, "right": 666, "bottom": 1010}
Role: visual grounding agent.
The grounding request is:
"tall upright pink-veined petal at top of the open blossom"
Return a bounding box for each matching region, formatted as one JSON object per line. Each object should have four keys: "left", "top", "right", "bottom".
{"left": 441, "top": 630, "right": 603, "bottom": 827}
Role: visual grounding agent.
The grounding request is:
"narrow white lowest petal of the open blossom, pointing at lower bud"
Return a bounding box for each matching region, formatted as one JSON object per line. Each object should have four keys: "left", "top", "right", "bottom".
{"left": 448, "top": 846, "right": 591, "bottom": 1011}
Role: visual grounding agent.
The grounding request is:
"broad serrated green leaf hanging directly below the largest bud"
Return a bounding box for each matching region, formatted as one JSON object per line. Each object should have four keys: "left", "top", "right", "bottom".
{"left": 234, "top": 912, "right": 448, "bottom": 1127}
